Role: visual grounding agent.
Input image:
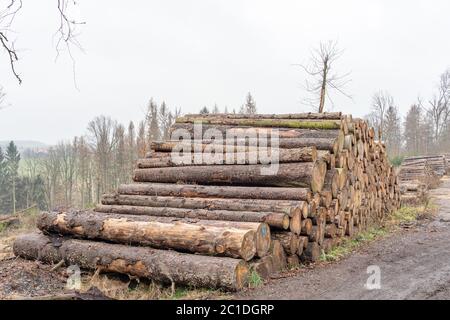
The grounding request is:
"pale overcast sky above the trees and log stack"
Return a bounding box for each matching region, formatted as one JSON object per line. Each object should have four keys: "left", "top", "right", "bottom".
{"left": 0, "top": 0, "right": 450, "bottom": 144}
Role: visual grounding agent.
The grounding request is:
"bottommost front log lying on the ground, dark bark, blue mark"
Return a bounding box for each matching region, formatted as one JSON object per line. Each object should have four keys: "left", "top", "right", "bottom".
{"left": 14, "top": 233, "right": 249, "bottom": 290}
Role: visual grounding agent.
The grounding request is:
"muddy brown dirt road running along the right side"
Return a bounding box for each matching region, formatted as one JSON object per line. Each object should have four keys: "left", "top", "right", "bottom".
{"left": 241, "top": 178, "right": 450, "bottom": 299}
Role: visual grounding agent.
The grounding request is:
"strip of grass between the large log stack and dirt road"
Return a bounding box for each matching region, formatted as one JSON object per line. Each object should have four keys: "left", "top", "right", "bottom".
{"left": 321, "top": 203, "right": 437, "bottom": 262}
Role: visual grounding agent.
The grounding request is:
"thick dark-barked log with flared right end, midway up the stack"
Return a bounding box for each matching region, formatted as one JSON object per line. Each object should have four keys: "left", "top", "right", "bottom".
{"left": 134, "top": 161, "right": 326, "bottom": 192}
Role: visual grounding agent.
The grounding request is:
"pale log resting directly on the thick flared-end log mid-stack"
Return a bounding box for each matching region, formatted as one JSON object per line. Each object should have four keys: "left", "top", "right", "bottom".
{"left": 136, "top": 147, "right": 317, "bottom": 169}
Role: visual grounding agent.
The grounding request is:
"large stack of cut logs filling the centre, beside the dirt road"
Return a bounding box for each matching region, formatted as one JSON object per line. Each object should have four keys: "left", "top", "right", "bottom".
{"left": 14, "top": 113, "right": 400, "bottom": 290}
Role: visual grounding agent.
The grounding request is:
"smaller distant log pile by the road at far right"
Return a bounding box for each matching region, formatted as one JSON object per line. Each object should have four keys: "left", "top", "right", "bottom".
{"left": 398, "top": 155, "right": 448, "bottom": 205}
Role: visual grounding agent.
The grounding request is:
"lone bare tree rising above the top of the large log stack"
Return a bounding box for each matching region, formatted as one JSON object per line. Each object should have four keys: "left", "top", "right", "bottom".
{"left": 299, "top": 41, "right": 351, "bottom": 112}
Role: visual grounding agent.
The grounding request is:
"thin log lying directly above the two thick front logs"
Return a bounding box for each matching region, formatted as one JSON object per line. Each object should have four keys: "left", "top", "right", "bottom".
{"left": 95, "top": 205, "right": 289, "bottom": 230}
